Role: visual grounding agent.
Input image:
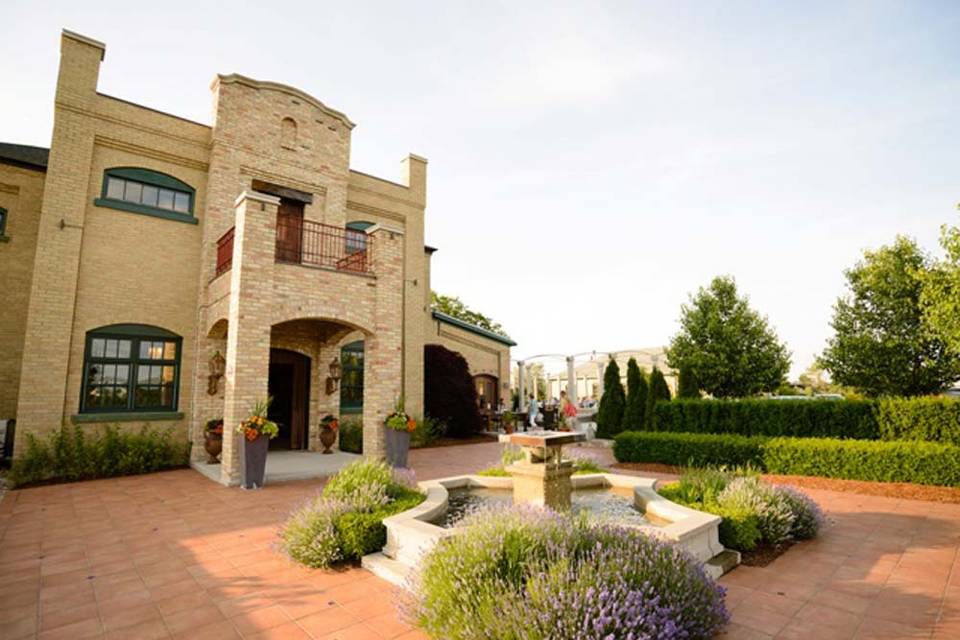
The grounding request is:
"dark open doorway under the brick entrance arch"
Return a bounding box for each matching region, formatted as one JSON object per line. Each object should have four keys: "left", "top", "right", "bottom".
{"left": 267, "top": 349, "right": 310, "bottom": 449}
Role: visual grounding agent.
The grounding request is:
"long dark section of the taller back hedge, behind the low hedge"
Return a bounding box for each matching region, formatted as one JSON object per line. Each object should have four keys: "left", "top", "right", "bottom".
{"left": 653, "top": 399, "right": 880, "bottom": 440}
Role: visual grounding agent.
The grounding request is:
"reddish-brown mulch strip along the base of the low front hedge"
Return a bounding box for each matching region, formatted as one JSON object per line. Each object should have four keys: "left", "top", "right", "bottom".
{"left": 613, "top": 462, "right": 960, "bottom": 502}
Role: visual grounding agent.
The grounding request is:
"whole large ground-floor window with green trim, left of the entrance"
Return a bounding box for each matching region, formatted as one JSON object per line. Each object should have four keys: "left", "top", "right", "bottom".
{"left": 80, "top": 324, "right": 183, "bottom": 413}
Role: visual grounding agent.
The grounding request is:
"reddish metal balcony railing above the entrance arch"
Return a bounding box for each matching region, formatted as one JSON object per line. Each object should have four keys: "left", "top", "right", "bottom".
{"left": 216, "top": 218, "right": 373, "bottom": 276}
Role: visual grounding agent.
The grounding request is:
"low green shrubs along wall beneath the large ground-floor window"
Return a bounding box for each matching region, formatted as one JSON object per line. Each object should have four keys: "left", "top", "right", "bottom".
{"left": 8, "top": 425, "right": 190, "bottom": 486}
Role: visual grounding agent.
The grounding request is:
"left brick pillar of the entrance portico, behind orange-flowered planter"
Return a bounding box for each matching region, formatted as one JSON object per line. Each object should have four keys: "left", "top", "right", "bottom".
{"left": 220, "top": 191, "right": 280, "bottom": 485}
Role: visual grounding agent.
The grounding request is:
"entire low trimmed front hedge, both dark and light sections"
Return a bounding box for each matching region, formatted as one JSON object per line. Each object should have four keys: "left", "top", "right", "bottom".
{"left": 613, "top": 431, "right": 960, "bottom": 486}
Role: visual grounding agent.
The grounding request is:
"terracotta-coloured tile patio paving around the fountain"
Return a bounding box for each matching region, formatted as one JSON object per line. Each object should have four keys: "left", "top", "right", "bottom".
{"left": 0, "top": 443, "right": 960, "bottom": 640}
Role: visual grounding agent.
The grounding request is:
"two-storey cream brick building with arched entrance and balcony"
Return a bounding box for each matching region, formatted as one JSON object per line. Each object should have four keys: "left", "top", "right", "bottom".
{"left": 0, "top": 31, "right": 513, "bottom": 484}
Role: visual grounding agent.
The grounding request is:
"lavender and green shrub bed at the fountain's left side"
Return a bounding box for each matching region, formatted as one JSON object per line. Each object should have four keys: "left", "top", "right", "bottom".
{"left": 280, "top": 460, "right": 424, "bottom": 567}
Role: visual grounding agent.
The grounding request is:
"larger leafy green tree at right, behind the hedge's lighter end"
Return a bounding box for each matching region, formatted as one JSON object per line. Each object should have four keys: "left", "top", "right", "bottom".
{"left": 819, "top": 236, "right": 960, "bottom": 396}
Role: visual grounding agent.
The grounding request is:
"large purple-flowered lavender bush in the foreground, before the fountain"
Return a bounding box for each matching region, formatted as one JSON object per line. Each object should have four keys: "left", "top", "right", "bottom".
{"left": 408, "top": 507, "right": 728, "bottom": 640}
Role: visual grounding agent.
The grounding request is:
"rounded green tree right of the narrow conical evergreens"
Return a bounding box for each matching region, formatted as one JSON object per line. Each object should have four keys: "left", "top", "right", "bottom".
{"left": 667, "top": 276, "right": 790, "bottom": 398}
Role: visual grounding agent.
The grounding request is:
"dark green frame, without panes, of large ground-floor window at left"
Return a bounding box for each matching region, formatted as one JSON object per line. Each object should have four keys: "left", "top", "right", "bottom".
{"left": 78, "top": 324, "right": 183, "bottom": 415}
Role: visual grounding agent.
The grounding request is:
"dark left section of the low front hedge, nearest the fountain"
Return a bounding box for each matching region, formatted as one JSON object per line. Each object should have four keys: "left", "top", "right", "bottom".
{"left": 613, "top": 428, "right": 765, "bottom": 467}
